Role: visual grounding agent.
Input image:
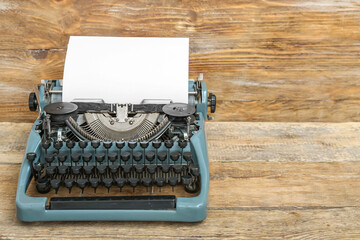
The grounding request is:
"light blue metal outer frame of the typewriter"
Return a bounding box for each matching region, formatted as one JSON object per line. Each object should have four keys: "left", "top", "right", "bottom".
{"left": 16, "top": 80, "right": 209, "bottom": 222}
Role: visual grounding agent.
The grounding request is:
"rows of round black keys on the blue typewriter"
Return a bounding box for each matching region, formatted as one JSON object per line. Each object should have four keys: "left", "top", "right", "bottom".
{"left": 26, "top": 140, "right": 200, "bottom": 193}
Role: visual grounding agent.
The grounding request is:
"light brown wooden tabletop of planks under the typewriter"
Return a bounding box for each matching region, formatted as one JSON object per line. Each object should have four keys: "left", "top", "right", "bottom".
{"left": 0, "top": 122, "right": 360, "bottom": 239}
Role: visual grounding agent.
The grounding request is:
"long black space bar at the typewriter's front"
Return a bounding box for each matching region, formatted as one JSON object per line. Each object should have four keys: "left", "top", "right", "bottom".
{"left": 49, "top": 195, "right": 176, "bottom": 210}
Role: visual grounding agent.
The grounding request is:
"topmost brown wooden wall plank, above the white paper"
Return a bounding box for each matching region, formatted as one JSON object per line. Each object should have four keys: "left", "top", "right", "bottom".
{"left": 0, "top": 0, "right": 359, "bottom": 49}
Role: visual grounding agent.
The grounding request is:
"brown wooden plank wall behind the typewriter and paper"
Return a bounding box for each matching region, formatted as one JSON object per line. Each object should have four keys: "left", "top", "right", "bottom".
{"left": 0, "top": 0, "right": 360, "bottom": 122}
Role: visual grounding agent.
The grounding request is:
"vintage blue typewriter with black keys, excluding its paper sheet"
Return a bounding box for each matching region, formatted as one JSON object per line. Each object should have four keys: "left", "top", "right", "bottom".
{"left": 16, "top": 74, "right": 216, "bottom": 222}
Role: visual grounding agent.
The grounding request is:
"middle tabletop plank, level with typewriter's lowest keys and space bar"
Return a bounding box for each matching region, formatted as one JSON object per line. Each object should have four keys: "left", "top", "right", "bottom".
{"left": 0, "top": 162, "right": 360, "bottom": 208}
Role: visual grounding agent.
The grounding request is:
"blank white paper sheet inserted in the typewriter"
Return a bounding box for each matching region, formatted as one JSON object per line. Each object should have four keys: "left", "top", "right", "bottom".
{"left": 63, "top": 36, "right": 189, "bottom": 104}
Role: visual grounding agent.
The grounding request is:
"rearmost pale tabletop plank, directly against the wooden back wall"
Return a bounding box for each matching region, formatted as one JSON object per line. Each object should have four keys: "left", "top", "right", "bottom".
{"left": 0, "top": 121, "right": 360, "bottom": 164}
